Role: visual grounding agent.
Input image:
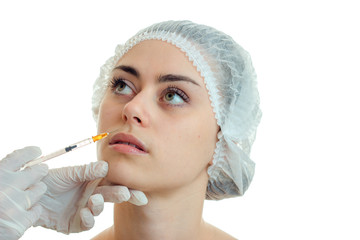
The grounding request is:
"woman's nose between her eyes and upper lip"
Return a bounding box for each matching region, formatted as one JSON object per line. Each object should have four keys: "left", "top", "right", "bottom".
{"left": 122, "top": 93, "right": 149, "bottom": 127}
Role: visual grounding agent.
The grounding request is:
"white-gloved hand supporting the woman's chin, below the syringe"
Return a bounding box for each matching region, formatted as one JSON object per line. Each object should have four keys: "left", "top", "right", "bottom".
{"left": 34, "top": 161, "right": 147, "bottom": 234}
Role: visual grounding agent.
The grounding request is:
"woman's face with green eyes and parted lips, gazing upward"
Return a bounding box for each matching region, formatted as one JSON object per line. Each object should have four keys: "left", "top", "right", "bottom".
{"left": 97, "top": 40, "right": 218, "bottom": 192}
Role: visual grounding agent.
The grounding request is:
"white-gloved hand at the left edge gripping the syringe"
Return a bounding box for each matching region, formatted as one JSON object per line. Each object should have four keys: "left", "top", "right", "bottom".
{"left": 0, "top": 147, "right": 48, "bottom": 240}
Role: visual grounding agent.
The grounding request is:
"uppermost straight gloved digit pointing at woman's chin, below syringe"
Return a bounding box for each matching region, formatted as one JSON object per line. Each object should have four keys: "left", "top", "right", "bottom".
{"left": 50, "top": 161, "right": 108, "bottom": 186}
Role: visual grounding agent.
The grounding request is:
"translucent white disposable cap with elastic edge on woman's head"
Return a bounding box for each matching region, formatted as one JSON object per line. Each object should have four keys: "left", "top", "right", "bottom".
{"left": 92, "top": 21, "right": 261, "bottom": 200}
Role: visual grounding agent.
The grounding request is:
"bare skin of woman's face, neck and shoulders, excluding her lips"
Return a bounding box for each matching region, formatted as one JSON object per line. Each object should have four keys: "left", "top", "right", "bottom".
{"left": 95, "top": 40, "right": 233, "bottom": 239}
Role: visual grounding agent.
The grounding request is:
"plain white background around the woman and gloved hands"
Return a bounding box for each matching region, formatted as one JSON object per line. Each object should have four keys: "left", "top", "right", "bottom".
{"left": 0, "top": 0, "right": 360, "bottom": 240}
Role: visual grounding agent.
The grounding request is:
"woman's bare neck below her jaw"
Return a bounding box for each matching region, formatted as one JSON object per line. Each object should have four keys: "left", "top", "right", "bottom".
{"left": 112, "top": 172, "right": 207, "bottom": 240}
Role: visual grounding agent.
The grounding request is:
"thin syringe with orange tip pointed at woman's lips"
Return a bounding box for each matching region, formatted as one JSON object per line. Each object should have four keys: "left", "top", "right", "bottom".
{"left": 22, "top": 132, "right": 109, "bottom": 169}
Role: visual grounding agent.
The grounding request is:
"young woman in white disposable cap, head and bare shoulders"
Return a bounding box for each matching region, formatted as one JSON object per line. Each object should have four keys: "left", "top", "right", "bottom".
{"left": 89, "top": 21, "right": 261, "bottom": 240}
